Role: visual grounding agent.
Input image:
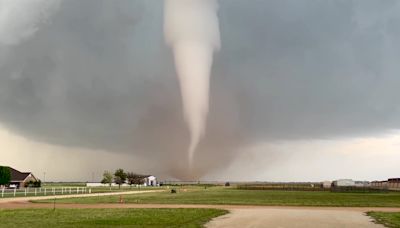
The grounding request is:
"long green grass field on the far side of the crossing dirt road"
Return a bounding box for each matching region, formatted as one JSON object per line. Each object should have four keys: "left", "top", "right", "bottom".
{"left": 34, "top": 187, "right": 400, "bottom": 207}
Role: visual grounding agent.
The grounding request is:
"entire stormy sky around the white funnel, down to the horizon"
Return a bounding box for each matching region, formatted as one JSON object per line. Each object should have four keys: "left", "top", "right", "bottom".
{"left": 0, "top": 0, "right": 400, "bottom": 181}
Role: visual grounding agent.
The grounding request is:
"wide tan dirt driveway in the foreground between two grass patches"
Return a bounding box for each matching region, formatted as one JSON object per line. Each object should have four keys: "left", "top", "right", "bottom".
{"left": 206, "top": 208, "right": 383, "bottom": 228}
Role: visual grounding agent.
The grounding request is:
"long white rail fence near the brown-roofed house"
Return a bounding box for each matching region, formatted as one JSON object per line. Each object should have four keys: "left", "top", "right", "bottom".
{"left": 0, "top": 187, "right": 92, "bottom": 198}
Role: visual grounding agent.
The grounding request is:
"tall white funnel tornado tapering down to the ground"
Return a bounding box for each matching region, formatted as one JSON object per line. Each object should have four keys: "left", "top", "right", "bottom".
{"left": 164, "top": 0, "right": 221, "bottom": 167}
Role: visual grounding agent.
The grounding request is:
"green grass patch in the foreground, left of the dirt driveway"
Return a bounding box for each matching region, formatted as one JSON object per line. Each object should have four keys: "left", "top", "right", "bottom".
{"left": 0, "top": 209, "right": 227, "bottom": 228}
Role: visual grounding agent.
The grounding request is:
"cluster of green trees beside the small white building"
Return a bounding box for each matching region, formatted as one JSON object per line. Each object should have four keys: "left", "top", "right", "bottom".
{"left": 101, "top": 169, "right": 146, "bottom": 188}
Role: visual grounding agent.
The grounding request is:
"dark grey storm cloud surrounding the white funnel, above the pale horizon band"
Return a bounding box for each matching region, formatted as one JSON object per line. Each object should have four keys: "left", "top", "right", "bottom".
{"left": 0, "top": 0, "right": 400, "bottom": 177}
